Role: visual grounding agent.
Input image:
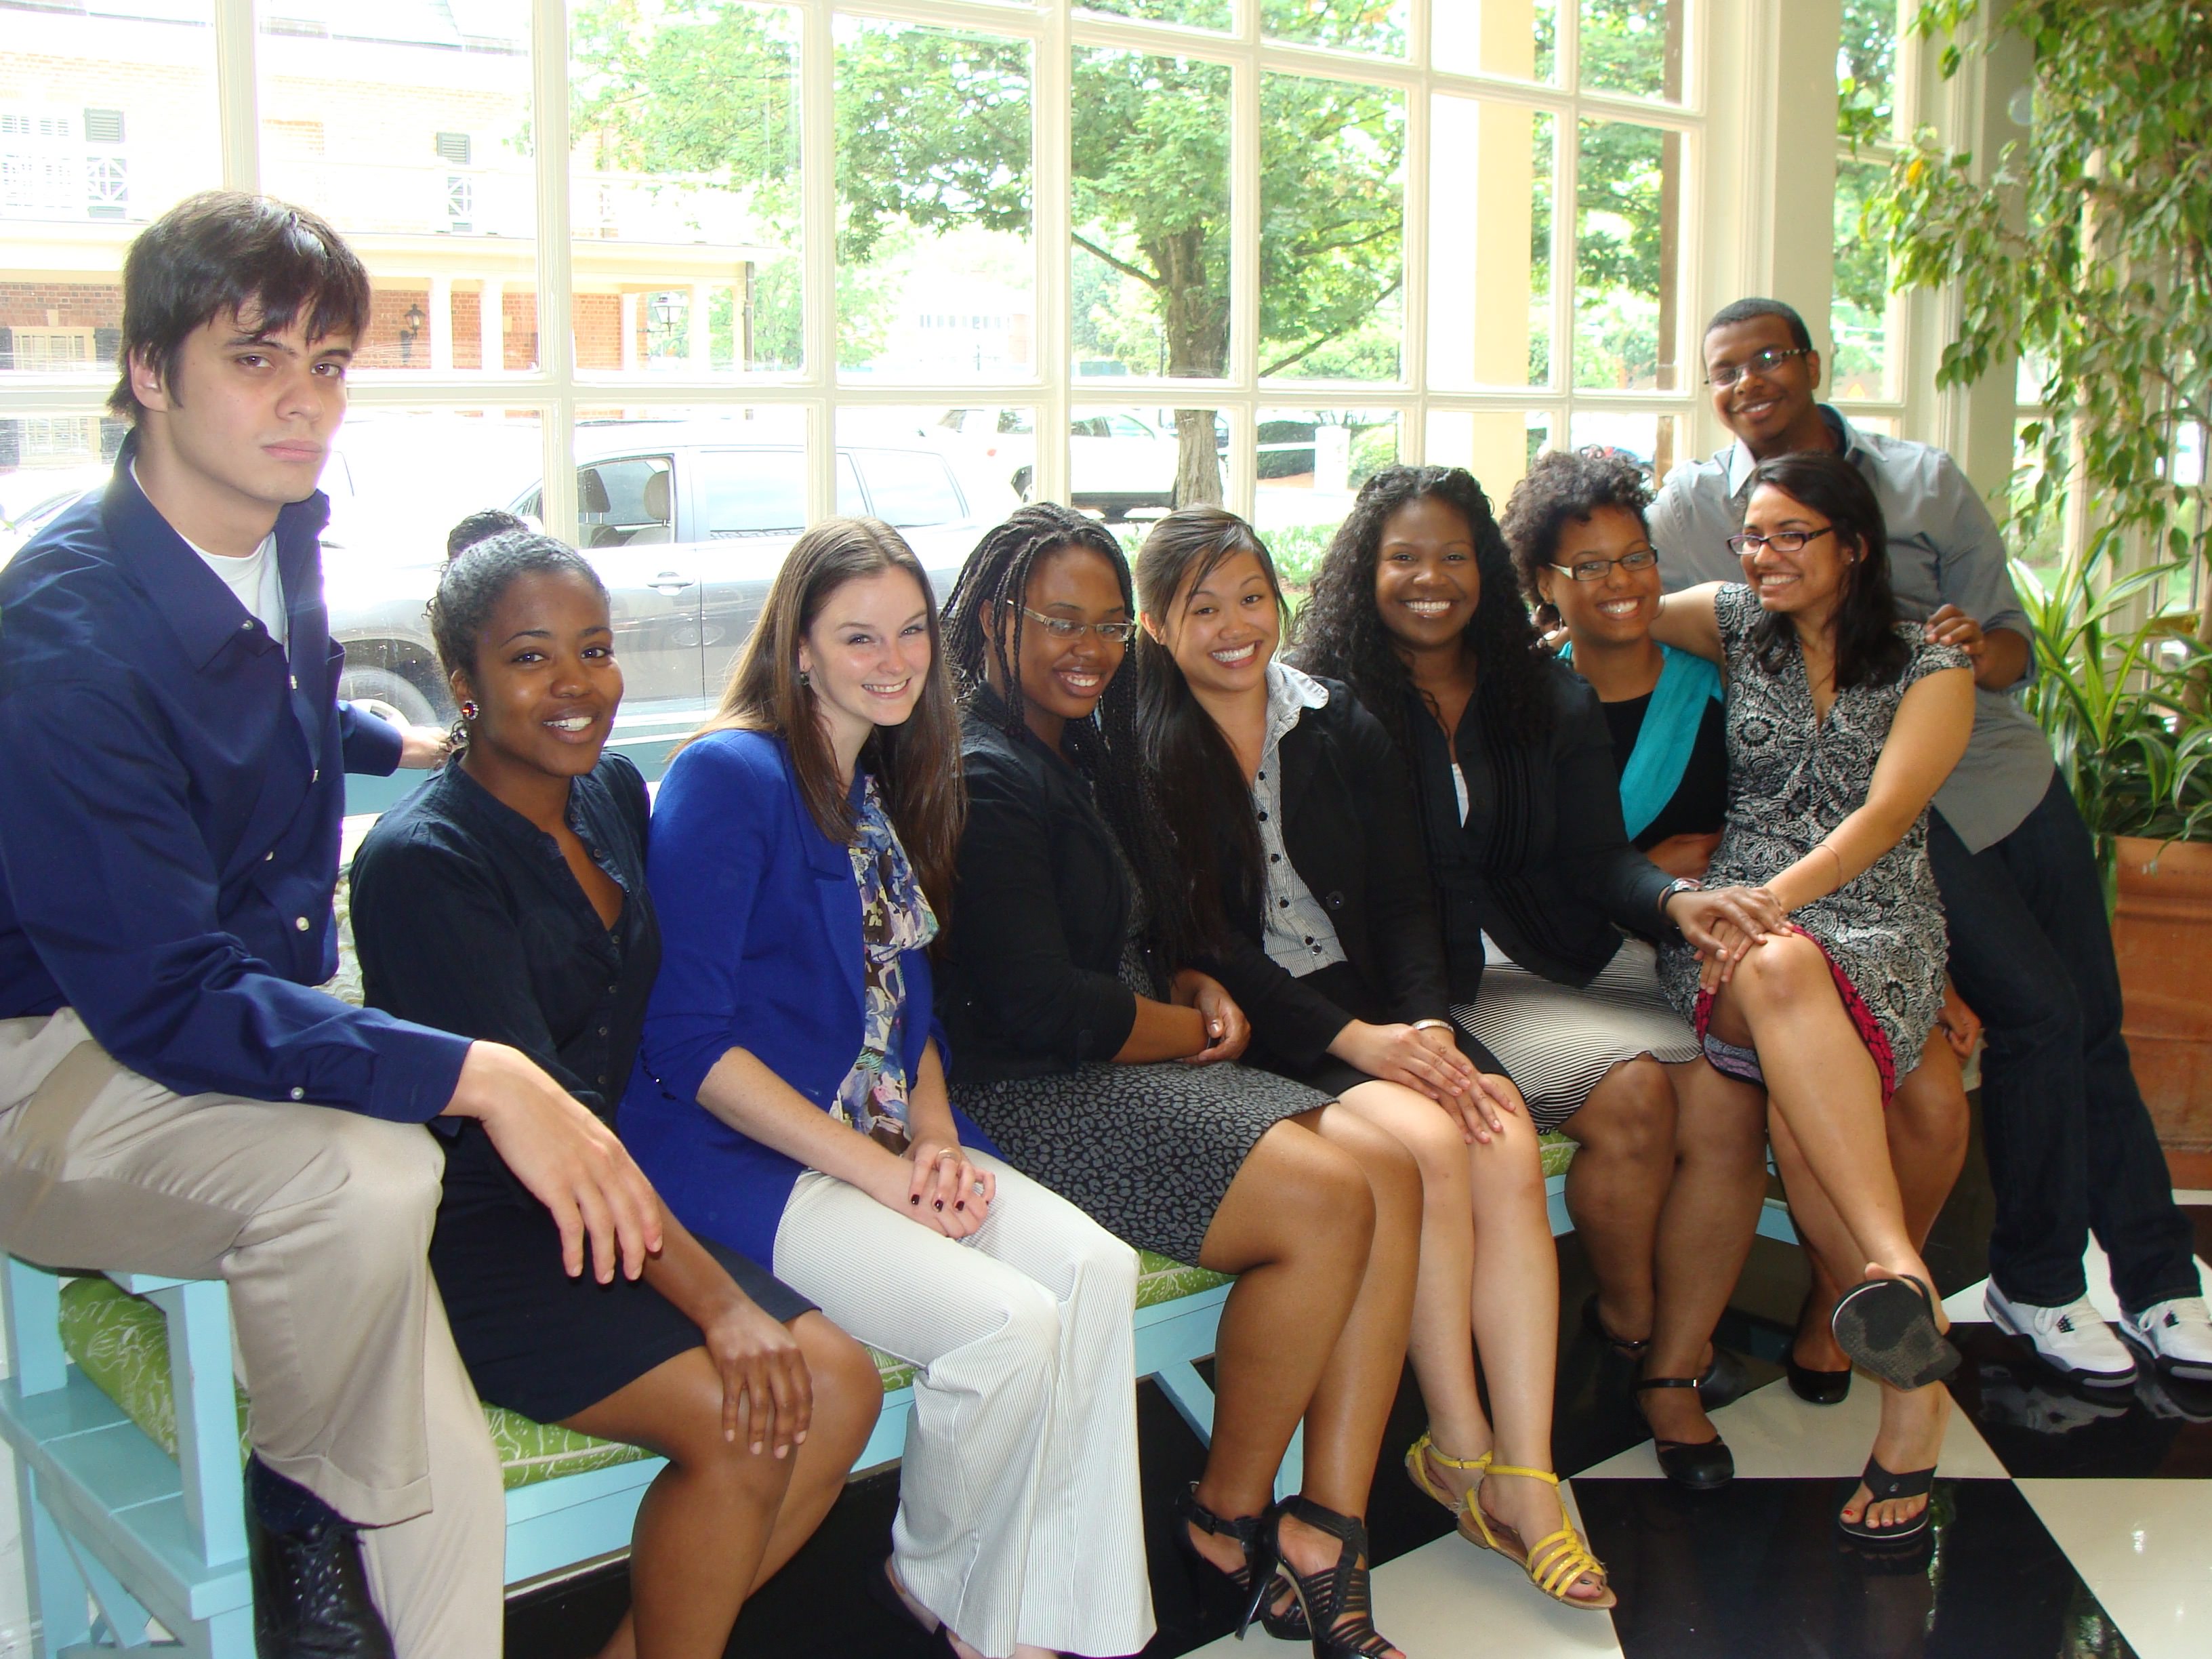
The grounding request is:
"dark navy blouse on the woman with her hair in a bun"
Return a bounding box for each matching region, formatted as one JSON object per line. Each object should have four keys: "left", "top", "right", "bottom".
{"left": 352, "top": 754, "right": 661, "bottom": 1124}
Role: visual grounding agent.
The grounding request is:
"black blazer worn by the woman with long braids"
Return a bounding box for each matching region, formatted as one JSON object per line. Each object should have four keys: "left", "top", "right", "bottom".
{"left": 936, "top": 690, "right": 1137, "bottom": 1082}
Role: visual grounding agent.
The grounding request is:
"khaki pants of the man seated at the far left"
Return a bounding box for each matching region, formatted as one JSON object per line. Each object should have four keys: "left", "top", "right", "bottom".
{"left": 0, "top": 1008, "right": 504, "bottom": 1659}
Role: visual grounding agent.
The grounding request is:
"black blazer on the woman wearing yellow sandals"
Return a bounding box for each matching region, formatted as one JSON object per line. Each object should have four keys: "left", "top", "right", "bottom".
{"left": 1206, "top": 679, "right": 1451, "bottom": 1071}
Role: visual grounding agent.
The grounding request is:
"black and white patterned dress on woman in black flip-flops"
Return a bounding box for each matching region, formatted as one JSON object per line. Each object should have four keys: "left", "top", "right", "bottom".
{"left": 1659, "top": 584, "right": 1969, "bottom": 1095}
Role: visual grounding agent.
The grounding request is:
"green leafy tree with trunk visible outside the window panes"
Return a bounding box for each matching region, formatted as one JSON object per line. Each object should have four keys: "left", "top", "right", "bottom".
{"left": 573, "top": 0, "right": 1405, "bottom": 500}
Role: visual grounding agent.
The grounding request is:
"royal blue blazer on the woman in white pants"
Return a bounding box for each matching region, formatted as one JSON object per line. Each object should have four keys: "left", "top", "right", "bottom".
{"left": 617, "top": 732, "right": 996, "bottom": 1263}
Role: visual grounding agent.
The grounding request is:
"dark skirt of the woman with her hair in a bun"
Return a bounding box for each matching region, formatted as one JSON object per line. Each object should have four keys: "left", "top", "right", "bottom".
{"left": 429, "top": 1124, "right": 814, "bottom": 1422}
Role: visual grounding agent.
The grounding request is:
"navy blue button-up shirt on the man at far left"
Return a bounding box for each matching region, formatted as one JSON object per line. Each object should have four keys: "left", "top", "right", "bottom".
{"left": 0, "top": 438, "right": 469, "bottom": 1122}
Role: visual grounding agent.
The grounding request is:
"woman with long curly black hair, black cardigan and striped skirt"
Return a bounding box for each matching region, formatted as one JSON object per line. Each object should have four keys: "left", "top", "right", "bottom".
{"left": 1296, "top": 467, "right": 1781, "bottom": 1486}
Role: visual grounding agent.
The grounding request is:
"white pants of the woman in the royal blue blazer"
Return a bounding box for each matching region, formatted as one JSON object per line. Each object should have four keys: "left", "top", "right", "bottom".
{"left": 774, "top": 1153, "right": 1153, "bottom": 1659}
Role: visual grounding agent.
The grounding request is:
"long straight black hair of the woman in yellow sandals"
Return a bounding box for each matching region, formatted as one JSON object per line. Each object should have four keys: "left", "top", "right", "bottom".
{"left": 1137, "top": 506, "right": 1283, "bottom": 940}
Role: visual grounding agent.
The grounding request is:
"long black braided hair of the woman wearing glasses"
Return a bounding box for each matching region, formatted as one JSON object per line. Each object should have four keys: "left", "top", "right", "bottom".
{"left": 945, "top": 513, "right": 1199, "bottom": 966}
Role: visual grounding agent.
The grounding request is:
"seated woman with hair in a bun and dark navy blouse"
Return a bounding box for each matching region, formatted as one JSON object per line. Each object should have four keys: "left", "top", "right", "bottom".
{"left": 352, "top": 513, "right": 882, "bottom": 1659}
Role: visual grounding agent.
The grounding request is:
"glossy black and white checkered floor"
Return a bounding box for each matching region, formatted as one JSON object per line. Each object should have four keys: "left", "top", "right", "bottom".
{"left": 506, "top": 1155, "right": 2212, "bottom": 1659}
